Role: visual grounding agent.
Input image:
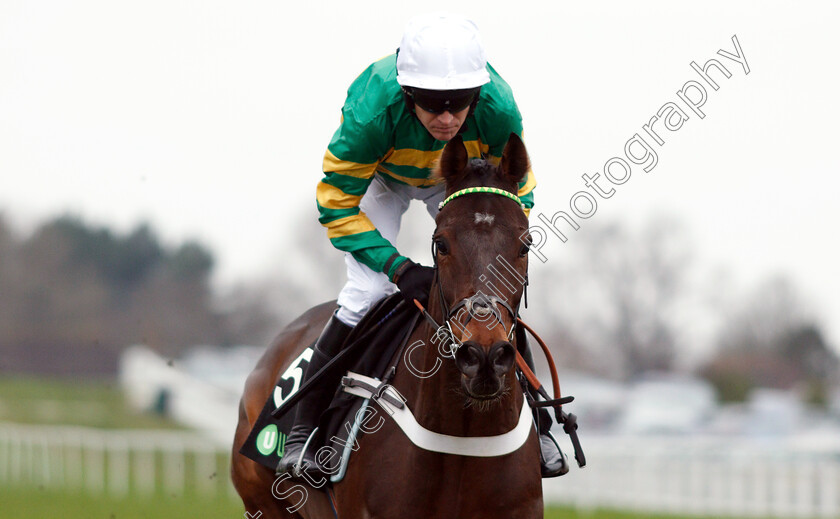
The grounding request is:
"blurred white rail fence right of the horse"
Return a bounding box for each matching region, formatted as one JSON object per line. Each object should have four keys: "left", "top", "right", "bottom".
{"left": 543, "top": 437, "right": 840, "bottom": 518}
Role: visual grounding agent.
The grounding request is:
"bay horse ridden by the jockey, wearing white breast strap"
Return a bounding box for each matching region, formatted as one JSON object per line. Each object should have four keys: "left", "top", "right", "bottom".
{"left": 231, "top": 134, "right": 543, "bottom": 519}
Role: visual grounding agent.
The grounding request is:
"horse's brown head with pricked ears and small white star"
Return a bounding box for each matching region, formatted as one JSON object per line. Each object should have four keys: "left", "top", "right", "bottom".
{"left": 433, "top": 134, "right": 528, "bottom": 410}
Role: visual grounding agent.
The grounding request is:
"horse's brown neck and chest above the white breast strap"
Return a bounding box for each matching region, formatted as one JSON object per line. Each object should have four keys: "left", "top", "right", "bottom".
{"left": 394, "top": 287, "right": 523, "bottom": 436}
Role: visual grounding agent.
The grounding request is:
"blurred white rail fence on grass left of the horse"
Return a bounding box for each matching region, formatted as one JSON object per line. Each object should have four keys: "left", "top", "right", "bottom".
{"left": 0, "top": 423, "right": 246, "bottom": 499}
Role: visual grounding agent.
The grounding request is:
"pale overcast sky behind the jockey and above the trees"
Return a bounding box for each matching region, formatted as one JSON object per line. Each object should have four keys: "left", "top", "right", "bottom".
{"left": 0, "top": 0, "right": 840, "bottom": 350}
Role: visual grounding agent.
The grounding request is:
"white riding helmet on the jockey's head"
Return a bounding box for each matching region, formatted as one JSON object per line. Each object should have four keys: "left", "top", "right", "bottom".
{"left": 397, "top": 13, "right": 490, "bottom": 90}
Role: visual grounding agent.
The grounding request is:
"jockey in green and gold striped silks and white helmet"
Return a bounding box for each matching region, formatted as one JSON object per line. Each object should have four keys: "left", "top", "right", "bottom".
{"left": 277, "top": 14, "right": 564, "bottom": 477}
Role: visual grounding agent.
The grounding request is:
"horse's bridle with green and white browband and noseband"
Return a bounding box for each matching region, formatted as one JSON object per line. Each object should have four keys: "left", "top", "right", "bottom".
{"left": 423, "top": 186, "right": 528, "bottom": 356}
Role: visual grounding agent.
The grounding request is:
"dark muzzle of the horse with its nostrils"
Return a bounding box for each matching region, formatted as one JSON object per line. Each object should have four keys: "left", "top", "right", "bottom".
{"left": 455, "top": 341, "right": 516, "bottom": 400}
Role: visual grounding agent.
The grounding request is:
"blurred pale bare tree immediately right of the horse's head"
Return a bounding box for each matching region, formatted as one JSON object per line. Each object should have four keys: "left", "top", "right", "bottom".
{"left": 530, "top": 218, "right": 690, "bottom": 378}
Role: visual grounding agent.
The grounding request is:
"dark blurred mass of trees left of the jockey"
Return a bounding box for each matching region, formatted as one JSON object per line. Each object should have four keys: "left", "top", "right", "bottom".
{"left": 0, "top": 216, "right": 229, "bottom": 373}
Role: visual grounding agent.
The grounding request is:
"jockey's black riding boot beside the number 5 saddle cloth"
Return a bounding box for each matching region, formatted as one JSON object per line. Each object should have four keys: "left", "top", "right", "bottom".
{"left": 276, "top": 315, "right": 353, "bottom": 476}
